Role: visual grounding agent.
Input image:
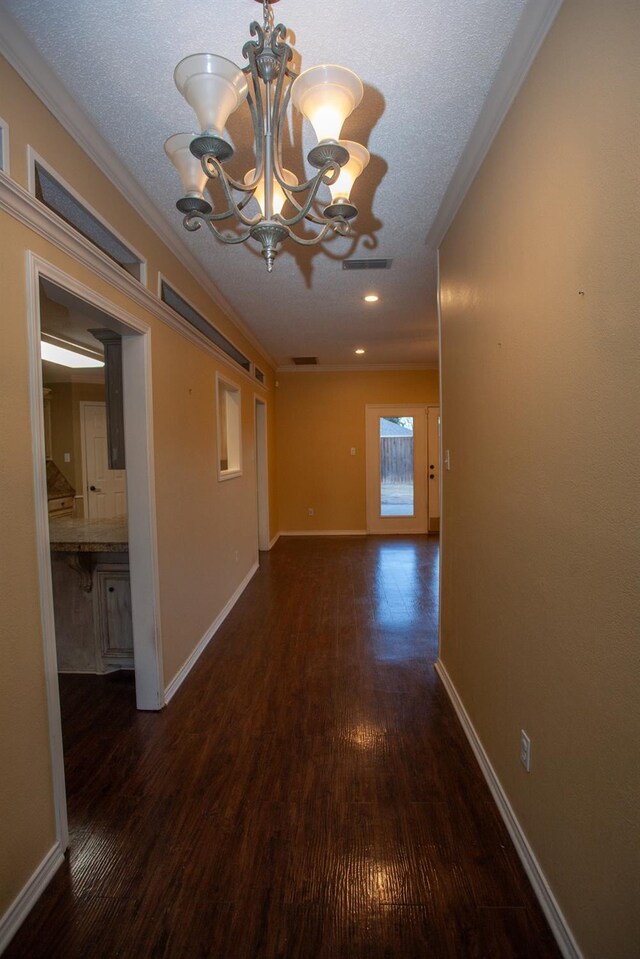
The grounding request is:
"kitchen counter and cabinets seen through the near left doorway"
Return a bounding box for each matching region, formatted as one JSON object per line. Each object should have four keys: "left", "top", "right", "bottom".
{"left": 39, "top": 277, "right": 134, "bottom": 674}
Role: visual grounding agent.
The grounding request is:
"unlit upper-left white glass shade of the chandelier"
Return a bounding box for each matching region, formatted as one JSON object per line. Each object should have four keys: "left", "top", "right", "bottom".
{"left": 173, "top": 53, "right": 249, "bottom": 138}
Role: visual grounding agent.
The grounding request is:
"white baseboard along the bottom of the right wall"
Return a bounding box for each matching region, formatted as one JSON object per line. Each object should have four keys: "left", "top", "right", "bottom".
{"left": 435, "top": 659, "right": 584, "bottom": 959}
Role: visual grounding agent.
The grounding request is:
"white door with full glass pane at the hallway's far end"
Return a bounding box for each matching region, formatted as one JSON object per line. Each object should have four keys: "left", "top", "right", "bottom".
{"left": 366, "top": 405, "right": 427, "bottom": 533}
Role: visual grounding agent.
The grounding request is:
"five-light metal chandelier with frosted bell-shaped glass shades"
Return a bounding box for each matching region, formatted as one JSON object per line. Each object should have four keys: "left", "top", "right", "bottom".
{"left": 164, "top": 0, "right": 369, "bottom": 273}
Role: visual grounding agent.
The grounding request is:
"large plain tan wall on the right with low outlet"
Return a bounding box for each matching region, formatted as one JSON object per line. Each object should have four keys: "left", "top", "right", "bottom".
{"left": 441, "top": 0, "right": 640, "bottom": 959}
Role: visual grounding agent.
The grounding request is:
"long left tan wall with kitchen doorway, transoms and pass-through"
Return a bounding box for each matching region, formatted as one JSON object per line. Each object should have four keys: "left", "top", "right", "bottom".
{"left": 0, "top": 52, "right": 277, "bottom": 916}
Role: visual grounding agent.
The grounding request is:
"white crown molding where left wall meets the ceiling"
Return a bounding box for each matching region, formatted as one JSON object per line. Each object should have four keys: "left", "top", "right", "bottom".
{"left": 0, "top": 7, "right": 276, "bottom": 368}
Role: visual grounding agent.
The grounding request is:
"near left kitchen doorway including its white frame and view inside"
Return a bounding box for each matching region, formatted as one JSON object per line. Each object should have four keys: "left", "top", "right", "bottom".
{"left": 27, "top": 253, "right": 164, "bottom": 849}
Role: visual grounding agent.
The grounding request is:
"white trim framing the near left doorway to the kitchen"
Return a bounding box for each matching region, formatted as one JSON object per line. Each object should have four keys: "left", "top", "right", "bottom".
{"left": 26, "top": 250, "right": 164, "bottom": 796}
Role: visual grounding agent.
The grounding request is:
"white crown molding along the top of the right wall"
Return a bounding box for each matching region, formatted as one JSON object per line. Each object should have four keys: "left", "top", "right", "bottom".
{"left": 427, "top": 0, "right": 563, "bottom": 250}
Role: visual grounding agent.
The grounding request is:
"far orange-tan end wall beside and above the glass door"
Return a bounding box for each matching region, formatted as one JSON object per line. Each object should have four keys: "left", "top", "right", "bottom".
{"left": 276, "top": 370, "right": 438, "bottom": 532}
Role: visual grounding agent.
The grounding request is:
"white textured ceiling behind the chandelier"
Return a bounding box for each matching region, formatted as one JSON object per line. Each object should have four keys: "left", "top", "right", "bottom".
{"left": 0, "top": 0, "right": 535, "bottom": 366}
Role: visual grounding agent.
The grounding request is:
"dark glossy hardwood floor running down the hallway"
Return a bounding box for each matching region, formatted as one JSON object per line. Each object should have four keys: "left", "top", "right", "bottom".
{"left": 6, "top": 537, "right": 560, "bottom": 959}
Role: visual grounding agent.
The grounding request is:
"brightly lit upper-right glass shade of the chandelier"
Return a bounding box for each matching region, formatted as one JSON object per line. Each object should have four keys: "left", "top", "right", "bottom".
{"left": 291, "top": 63, "right": 364, "bottom": 143}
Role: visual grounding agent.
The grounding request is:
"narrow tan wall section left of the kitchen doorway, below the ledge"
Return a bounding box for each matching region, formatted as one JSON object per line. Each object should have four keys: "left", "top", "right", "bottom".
{"left": 0, "top": 227, "right": 55, "bottom": 936}
